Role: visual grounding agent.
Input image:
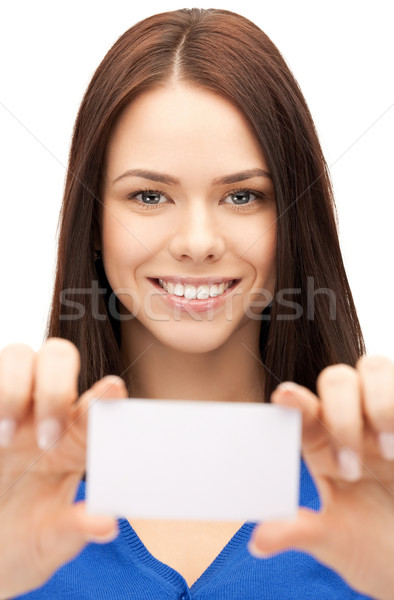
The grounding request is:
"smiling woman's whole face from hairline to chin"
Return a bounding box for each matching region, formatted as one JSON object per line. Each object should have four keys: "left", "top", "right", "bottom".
{"left": 101, "top": 84, "right": 276, "bottom": 352}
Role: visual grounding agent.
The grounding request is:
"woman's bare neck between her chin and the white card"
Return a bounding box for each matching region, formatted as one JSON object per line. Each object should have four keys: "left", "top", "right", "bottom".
{"left": 121, "top": 319, "right": 264, "bottom": 402}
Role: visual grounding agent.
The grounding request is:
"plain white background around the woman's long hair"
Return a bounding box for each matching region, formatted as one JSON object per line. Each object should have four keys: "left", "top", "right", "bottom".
{"left": 0, "top": 0, "right": 394, "bottom": 358}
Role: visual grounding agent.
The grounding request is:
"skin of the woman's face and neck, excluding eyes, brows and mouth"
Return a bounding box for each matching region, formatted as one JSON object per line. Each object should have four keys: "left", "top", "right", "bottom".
{"left": 101, "top": 84, "right": 276, "bottom": 401}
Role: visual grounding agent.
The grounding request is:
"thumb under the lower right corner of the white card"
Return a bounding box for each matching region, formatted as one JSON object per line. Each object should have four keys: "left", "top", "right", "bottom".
{"left": 248, "top": 508, "right": 326, "bottom": 558}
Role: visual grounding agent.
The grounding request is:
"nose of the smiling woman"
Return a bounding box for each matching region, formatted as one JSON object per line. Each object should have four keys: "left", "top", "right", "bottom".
{"left": 169, "top": 199, "right": 226, "bottom": 264}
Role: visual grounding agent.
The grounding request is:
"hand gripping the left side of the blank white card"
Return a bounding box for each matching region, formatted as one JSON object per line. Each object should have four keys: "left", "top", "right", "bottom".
{"left": 0, "top": 338, "right": 127, "bottom": 600}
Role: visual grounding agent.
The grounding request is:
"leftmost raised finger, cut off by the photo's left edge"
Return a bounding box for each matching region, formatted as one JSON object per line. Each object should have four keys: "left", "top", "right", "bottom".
{"left": 0, "top": 344, "right": 35, "bottom": 446}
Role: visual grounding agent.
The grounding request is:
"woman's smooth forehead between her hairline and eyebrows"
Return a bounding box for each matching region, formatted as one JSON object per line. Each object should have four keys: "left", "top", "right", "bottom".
{"left": 103, "top": 84, "right": 267, "bottom": 177}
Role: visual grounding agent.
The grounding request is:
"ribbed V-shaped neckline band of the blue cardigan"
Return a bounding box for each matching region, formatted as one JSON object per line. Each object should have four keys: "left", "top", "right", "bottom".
{"left": 119, "top": 519, "right": 257, "bottom": 592}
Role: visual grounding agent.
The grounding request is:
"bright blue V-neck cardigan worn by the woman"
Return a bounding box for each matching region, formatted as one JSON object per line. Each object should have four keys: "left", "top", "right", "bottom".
{"left": 14, "top": 461, "right": 367, "bottom": 600}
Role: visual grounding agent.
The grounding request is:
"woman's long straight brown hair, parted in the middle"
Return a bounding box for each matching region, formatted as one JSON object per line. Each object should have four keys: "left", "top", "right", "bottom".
{"left": 47, "top": 8, "right": 365, "bottom": 401}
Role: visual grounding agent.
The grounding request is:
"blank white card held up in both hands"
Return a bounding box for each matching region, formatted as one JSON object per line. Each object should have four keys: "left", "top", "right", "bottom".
{"left": 86, "top": 398, "right": 301, "bottom": 522}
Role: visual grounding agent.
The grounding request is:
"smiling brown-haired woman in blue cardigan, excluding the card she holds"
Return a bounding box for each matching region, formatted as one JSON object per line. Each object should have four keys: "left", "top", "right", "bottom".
{"left": 0, "top": 9, "right": 394, "bottom": 600}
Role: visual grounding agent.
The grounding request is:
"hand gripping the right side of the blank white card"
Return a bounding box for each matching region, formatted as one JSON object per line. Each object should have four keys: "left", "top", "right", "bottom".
{"left": 250, "top": 356, "right": 394, "bottom": 600}
